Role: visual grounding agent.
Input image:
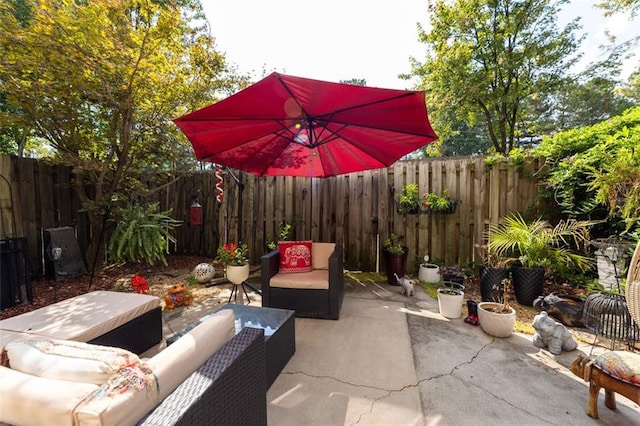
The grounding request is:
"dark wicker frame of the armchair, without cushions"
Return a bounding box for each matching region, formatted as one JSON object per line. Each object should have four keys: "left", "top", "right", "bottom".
{"left": 261, "top": 247, "right": 344, "bottom": 320}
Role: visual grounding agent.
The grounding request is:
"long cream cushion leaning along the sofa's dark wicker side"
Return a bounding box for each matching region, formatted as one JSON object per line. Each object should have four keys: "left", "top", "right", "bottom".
{"left": 147, "top": 309, "right": 236, "bottom": 400}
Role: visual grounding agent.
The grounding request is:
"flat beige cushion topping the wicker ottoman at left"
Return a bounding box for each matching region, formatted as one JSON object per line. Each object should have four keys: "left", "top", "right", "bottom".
{"left": 0, "top": 291, "right": 160, "bottom": 342}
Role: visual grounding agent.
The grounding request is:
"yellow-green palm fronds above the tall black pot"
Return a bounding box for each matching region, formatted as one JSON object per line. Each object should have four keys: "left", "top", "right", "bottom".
{"left": 487, "top": 213, "right": 594, "bottom": 272}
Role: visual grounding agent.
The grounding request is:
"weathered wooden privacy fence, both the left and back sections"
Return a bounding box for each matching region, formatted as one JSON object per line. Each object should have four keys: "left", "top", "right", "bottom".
{"left": 0, "top": 156, "right": 540, "bottom": 275}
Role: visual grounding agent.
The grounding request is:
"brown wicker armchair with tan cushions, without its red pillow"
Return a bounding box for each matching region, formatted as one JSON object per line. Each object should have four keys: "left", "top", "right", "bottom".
{"left": 261, "top": 242, "right": 344, "bottom": 320}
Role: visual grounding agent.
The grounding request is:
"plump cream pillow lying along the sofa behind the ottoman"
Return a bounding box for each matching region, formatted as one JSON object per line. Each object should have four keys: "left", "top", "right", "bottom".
{"left": 5, "top": 338, "right": 140, "bottom": 385}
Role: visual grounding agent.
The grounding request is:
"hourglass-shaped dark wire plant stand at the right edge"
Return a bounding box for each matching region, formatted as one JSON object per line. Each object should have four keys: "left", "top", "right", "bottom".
{"left": 582, "top": 239, "right": 640, "bottom": 350}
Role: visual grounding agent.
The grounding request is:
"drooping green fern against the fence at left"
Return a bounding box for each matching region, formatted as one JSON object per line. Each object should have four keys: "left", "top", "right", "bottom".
{"left": 109, "top": 203, "right": 181, "bottom": 265}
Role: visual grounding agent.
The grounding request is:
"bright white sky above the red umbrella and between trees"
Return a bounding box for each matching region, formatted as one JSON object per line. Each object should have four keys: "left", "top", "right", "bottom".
{"left": 203, "top": 0, "right": 640, "bottom": 89}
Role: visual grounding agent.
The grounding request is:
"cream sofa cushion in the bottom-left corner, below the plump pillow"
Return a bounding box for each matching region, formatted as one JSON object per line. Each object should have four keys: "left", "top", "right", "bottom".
{"left": 0, "top": 367, "right": 98, "bottom": 426}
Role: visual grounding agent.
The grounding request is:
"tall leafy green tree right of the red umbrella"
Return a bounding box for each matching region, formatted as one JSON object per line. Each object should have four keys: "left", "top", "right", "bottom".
{"left": 411, "top": 0, "right": 578, "bottom": 153}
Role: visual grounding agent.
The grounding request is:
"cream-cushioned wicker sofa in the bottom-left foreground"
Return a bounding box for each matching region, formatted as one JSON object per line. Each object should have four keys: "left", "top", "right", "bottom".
{"left": 0, "top": 295, "right": 267, "bottom": 425}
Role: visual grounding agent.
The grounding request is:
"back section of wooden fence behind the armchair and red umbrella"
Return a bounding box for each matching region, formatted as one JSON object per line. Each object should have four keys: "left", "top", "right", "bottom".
{"left": 155, "top": 157, "right": 540, "bottom": 271}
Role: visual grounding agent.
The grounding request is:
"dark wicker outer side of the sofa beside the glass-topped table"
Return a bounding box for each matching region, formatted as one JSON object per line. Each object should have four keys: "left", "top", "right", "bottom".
{"left": 139, "top": 328, "right": 267, "bottom": 426}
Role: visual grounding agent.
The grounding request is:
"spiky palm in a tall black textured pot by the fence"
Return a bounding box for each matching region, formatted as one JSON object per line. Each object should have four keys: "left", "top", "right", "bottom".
{"left": 489, "top": 213, "right": 595, "bottom": 306}
